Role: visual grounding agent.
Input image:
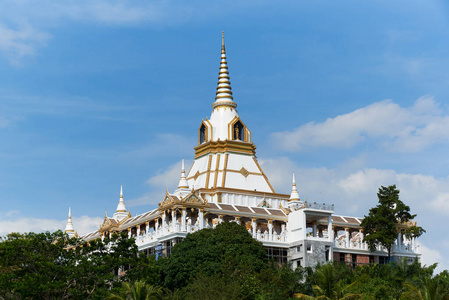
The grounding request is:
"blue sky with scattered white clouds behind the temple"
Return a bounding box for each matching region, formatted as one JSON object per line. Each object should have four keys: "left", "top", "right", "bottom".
{"left": 0, "top": 0, "right": 449, "bottom": 268}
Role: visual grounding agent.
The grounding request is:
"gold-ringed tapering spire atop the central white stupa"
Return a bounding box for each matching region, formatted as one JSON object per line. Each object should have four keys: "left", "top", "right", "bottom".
{"left": 212, "top": 32, "right": 237, "bottom": 108}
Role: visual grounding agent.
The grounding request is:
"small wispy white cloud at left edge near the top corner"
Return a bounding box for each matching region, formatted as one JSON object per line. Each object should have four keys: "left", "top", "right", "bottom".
{"left": 0, "top": 24, "right": 50, "bottom": 65}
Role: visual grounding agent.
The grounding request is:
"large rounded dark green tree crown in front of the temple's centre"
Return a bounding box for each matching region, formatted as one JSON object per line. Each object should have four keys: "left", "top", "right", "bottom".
{"left": 160, "top": 222, "right": 268, "bottom": 289}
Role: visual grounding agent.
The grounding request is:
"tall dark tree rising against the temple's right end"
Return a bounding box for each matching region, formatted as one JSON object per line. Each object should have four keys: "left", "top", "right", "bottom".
{"left": 361, "top": 185, "right": 425, "bottom": 260}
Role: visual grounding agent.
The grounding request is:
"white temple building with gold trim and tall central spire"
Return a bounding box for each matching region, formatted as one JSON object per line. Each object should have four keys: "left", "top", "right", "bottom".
{"left": 66, "top": 32, "right": 420, "bottom": 268}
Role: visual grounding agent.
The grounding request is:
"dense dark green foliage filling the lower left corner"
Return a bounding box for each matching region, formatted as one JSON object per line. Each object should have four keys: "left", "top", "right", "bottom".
{"left": 0, "top": 231, "right": 137, "bottom": 299}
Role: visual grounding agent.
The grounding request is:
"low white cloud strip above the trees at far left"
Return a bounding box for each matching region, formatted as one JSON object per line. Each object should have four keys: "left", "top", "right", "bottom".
{"left": 0, "top": 211, "right": 103, "bottom": 236}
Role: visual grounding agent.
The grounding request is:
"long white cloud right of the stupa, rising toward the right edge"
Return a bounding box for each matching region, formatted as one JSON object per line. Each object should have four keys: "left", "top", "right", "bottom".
{"left": 272, "top": 97, "right": 449, "bottom": 152}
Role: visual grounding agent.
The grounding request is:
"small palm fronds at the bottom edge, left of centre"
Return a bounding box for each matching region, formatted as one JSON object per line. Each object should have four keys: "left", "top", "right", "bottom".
{"left": 108, "top": 280, "right": 162, "bottom": 300}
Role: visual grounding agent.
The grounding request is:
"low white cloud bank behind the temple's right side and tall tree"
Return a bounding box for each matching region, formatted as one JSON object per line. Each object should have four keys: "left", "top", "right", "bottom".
{"left": 260, "top": 157, "right": 449, "bottom": 272}
